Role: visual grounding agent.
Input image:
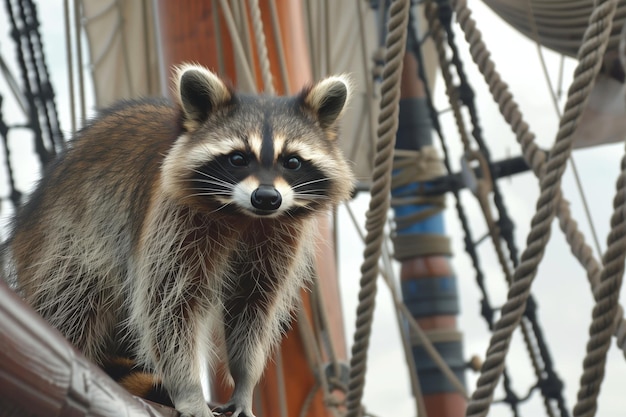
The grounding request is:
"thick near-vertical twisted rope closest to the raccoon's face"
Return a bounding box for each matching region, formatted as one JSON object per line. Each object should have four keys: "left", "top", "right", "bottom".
{"left": 346, "top": 0, "right": 410, "bottom": 417}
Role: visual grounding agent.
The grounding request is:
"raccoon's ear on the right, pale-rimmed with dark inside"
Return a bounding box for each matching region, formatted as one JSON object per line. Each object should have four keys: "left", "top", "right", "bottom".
{"left": 301, "top": 75, "right": 352, "bottom": 129}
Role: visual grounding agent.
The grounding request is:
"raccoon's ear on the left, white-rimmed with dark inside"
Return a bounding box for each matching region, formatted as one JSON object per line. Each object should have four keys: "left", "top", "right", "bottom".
{"left": 176, "top": 64, "right": 233, "bottom": 130}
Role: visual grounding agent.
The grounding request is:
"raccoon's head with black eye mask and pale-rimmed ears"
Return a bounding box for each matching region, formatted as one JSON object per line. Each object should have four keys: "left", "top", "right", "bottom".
{"left": 162, "top": 67, "right": 353, "bottom": 217}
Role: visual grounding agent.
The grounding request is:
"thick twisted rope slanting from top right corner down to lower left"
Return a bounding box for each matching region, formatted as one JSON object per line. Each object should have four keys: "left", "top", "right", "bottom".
{"left": 457, "top": 0, "right": 615, "bottom": 416}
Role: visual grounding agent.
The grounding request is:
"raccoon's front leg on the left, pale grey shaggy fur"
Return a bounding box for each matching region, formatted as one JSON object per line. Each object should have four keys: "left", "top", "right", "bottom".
{"left": 131, "top": 273, "right": 211, "bottom": 417}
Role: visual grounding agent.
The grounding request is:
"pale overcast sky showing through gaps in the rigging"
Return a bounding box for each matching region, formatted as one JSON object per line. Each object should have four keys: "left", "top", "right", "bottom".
{"left": 0, "top": 1, "right": 626, "bottom": 417}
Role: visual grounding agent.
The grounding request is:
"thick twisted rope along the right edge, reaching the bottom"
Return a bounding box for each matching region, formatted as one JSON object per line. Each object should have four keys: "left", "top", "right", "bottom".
{"left": 574, "top": 147, "right": 626, "bottom": 417}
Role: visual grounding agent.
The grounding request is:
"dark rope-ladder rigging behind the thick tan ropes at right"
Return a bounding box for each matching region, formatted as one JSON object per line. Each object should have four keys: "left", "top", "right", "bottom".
{"left": 409, "top": 2, "right": 569, "bottom": 416}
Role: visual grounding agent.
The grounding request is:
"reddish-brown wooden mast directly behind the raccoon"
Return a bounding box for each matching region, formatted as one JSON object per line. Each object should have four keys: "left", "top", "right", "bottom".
{"left": 157, "top": 0, "right": 347, "bottom": 417}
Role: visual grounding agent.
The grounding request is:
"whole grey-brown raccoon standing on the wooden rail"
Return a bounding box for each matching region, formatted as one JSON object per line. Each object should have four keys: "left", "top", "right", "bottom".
{"left": 6, "top": 65, "right": 353, "bottom": 417}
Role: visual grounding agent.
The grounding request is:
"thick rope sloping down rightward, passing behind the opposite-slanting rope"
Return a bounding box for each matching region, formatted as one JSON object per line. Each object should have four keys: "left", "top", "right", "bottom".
{"left": 448, "top": 1, "right": 626, "bottom": 357}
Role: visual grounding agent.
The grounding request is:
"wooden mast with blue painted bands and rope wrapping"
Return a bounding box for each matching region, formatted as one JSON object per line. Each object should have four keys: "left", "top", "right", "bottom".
{"left": 392, "top": 51, "right": 467, "bottom": 417}
